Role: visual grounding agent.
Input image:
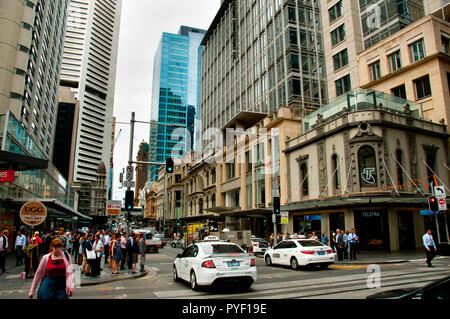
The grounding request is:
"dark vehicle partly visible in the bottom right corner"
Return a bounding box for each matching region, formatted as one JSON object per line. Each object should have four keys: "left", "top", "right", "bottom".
{"left": 367, "top": 276, "right": 450, "bottom": 301}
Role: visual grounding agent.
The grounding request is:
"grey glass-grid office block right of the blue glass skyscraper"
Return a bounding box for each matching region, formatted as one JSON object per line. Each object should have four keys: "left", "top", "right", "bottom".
{"left": 201, "top": 0, "right": 327, "bottom": 138}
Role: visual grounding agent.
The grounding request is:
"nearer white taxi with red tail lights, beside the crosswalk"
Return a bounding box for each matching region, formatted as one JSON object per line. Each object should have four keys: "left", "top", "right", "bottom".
{"left": 173, "top": 238, "right": 256, "bottom": 290}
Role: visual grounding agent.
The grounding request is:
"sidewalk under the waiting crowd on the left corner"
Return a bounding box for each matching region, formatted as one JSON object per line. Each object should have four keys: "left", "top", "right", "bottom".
{"left": 0, "top": 253, "right": 151, "bottom": 290}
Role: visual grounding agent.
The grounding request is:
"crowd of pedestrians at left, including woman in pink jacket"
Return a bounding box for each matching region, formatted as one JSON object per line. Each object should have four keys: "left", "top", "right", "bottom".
{"left": 0, "top": 228, "right": 146, "bottom": 299}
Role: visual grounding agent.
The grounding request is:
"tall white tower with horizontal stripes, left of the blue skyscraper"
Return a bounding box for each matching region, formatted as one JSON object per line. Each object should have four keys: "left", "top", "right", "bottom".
{"left": 61, "top": 0, "right": 122, "bottom": 182}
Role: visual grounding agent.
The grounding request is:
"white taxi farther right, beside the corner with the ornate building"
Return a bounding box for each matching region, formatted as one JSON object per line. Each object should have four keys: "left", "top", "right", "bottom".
{"left": 264, "top": 239, "right": 335, "bottom": 270}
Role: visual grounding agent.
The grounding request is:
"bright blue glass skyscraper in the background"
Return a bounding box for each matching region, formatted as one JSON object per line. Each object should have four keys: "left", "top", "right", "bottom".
{"left": 149, "top": 26, "right": 206, "bottom": 181}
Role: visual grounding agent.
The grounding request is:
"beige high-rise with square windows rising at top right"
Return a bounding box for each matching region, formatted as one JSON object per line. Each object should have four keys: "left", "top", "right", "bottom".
{"left": 320, "top": 0, "right": 430, "bottom": 101}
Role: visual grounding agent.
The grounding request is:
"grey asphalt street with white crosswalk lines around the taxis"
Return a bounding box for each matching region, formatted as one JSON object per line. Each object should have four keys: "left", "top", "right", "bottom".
{"left": 0, "top": 246, "right": 450, "bottom": 299}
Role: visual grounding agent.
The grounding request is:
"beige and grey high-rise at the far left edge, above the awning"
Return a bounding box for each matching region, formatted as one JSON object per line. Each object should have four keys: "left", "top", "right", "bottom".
{"left": 0, "top": 0, "right": 69, "bottom": 159}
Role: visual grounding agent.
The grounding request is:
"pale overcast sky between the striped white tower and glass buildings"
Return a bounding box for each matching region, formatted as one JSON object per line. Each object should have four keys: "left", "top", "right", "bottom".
{"left": 113, "top": 0, "right": 220, "bottom": 200}
